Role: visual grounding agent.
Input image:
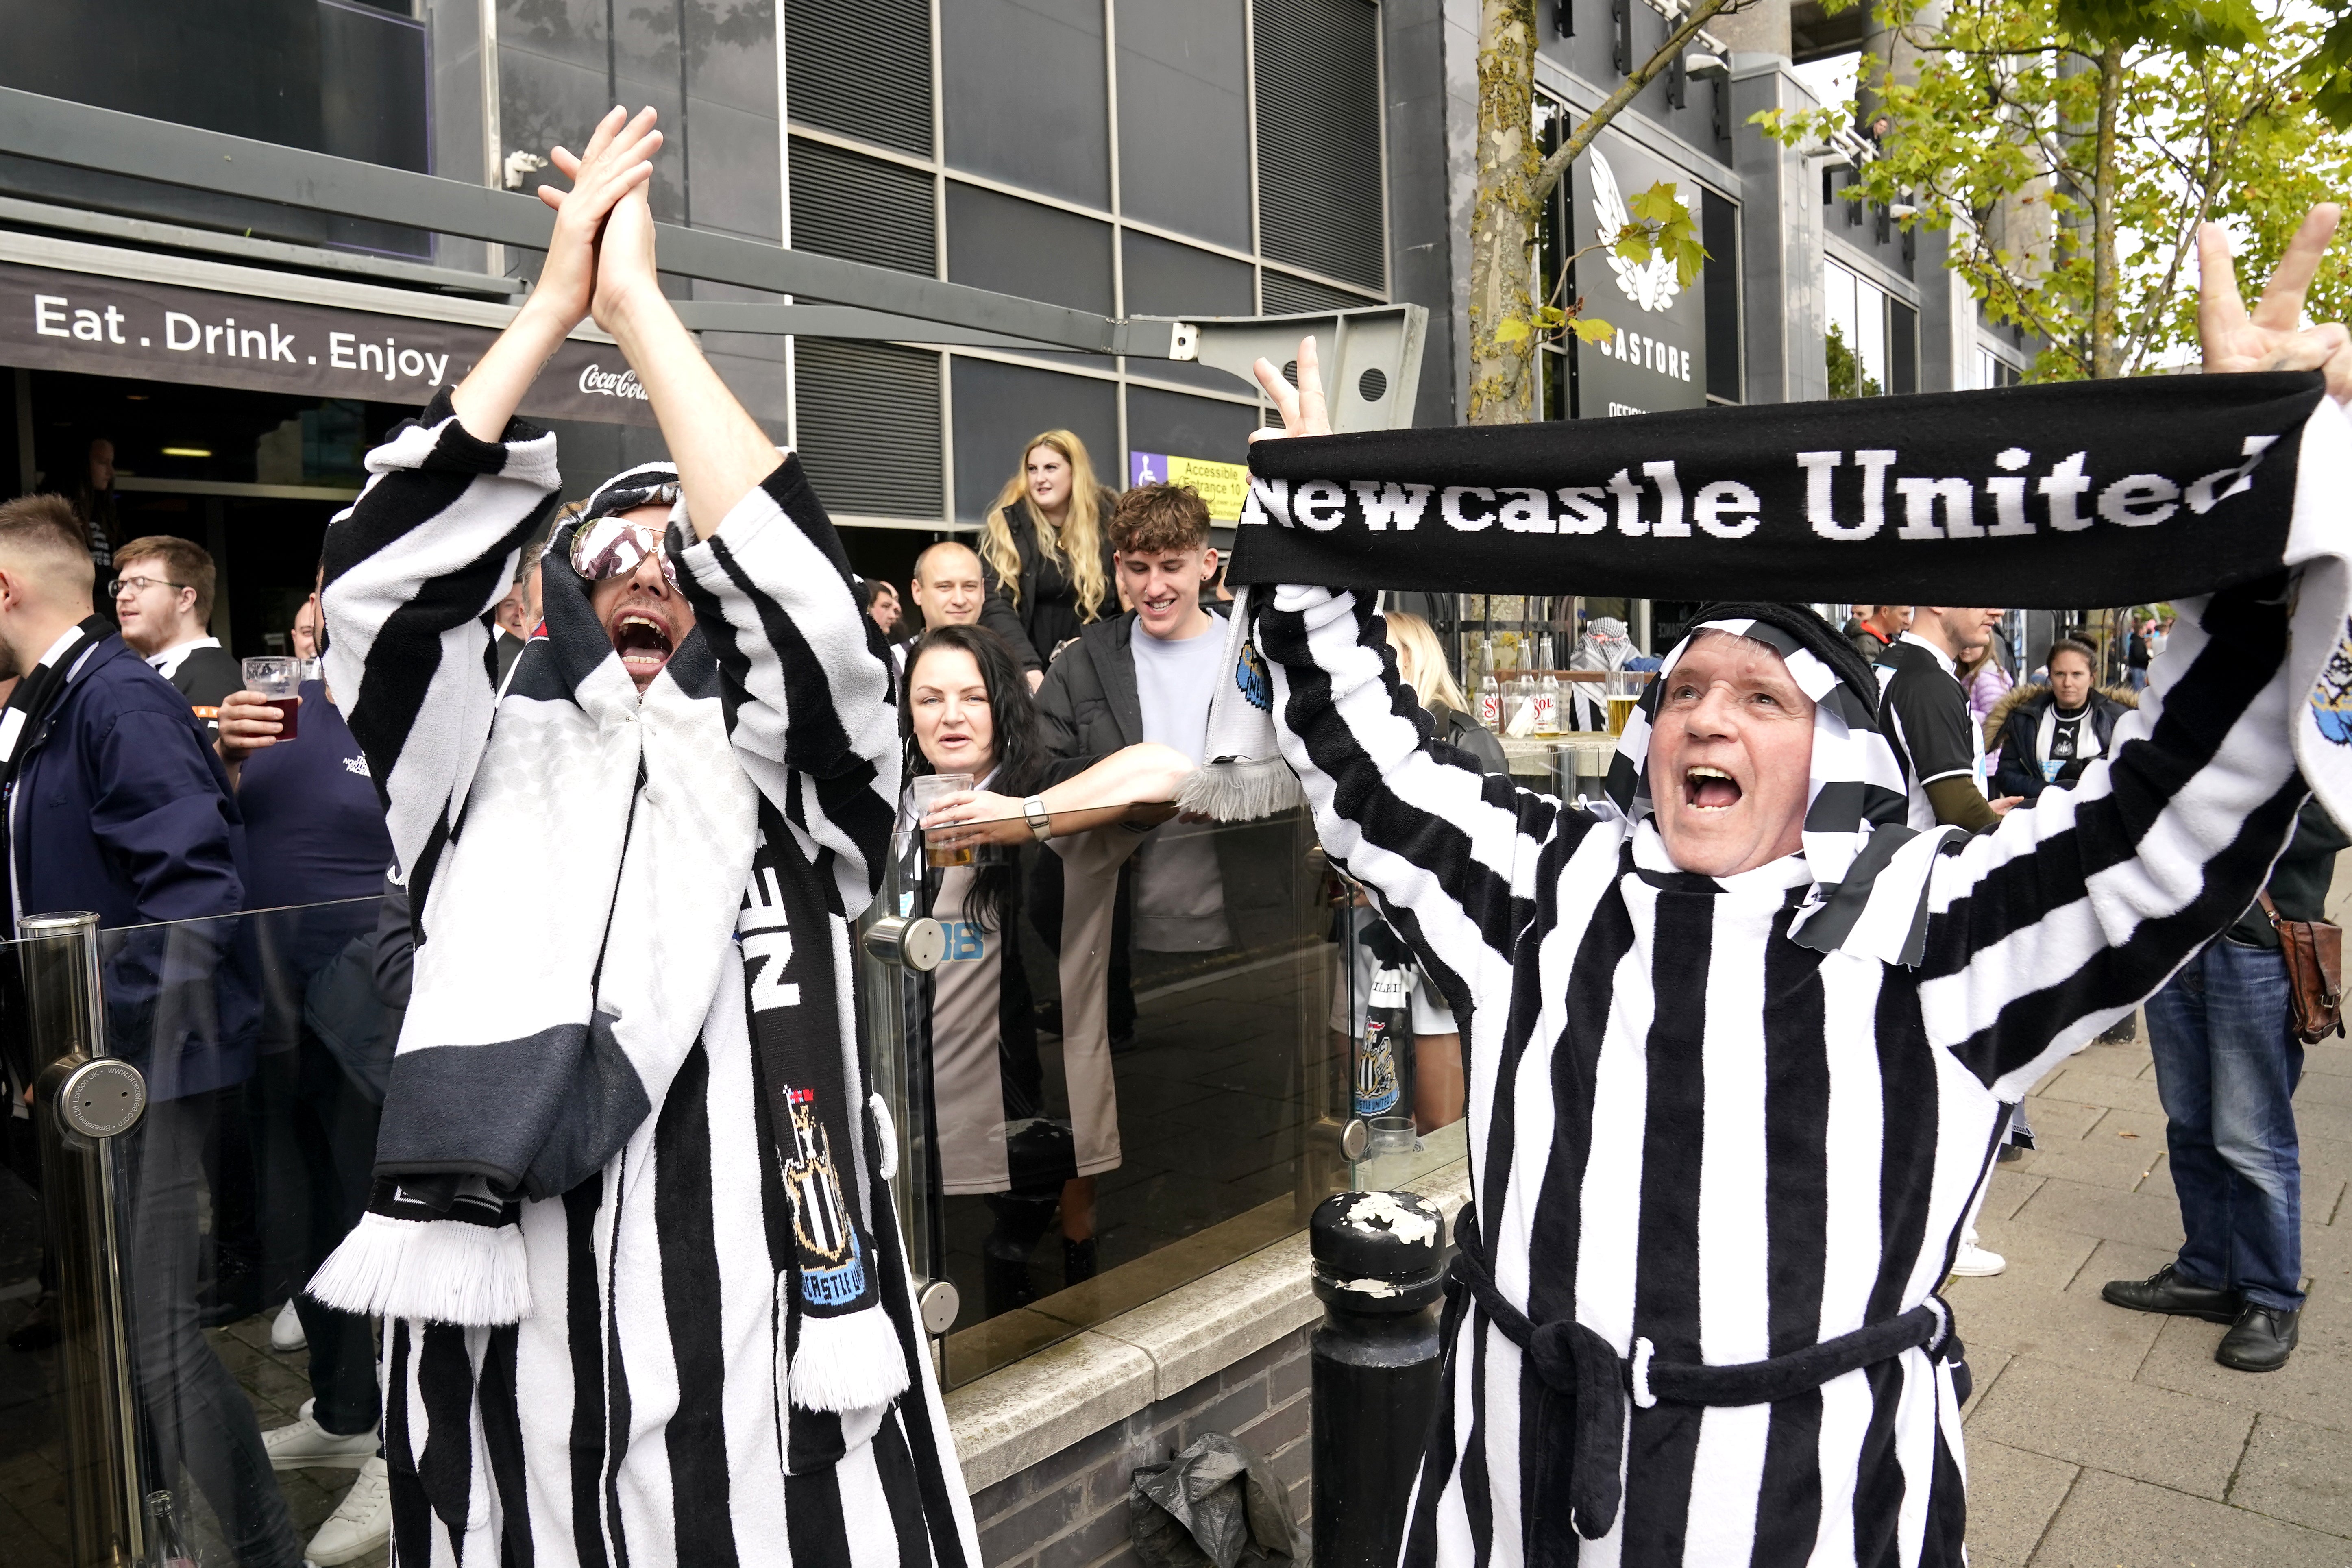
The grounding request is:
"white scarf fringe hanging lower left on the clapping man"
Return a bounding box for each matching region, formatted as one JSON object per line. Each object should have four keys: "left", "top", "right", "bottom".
{"left": 310, "top": 1213, "right": 531, "bottom": 1328}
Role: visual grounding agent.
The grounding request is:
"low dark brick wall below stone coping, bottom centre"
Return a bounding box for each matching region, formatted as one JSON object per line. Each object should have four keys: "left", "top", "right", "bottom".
{"left": 971, "top": 1328, "right": 1312, "bottom": 1568}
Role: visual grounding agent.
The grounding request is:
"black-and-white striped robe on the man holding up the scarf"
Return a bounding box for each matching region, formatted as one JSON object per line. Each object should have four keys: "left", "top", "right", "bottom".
{"left": 1258, "top": 581, "right": 2307, "bottom": 1568}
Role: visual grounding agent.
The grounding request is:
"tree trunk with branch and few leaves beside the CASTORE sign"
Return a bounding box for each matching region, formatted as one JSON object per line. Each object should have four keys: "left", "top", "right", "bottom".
{"left": 1470, "top": 0, "right": 1729, "bottom": 425}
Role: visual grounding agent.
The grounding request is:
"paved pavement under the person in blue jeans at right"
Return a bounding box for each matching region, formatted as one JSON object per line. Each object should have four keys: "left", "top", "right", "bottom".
{"left": 1950, "top": 973, "right": 2352, "bottom": 1568}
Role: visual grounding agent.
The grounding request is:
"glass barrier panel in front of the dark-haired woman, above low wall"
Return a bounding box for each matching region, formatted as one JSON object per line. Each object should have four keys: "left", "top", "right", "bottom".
{"left": 906, "top": 806, "right": 1348, "bottom": 1385}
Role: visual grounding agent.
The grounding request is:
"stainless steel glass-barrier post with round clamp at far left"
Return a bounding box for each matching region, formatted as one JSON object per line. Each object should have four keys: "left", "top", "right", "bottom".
{"left": 16, "top": 915, "right": 146, "bottom": 1568}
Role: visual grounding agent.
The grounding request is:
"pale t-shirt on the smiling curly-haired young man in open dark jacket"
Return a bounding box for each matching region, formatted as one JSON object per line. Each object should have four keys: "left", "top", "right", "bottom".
{"left": 1129, "top": 614, "right": 1233, "bottom": 952}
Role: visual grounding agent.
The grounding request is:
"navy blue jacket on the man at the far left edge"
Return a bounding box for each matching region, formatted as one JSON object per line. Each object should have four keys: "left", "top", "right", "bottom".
{"left": 7, "top": 637, "right": 252, "bottom": 1100}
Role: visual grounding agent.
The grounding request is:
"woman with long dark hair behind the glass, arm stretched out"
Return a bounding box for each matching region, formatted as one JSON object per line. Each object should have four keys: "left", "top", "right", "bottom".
{"left": 901, "top": 625, "right": 1190, "bottom": 1314}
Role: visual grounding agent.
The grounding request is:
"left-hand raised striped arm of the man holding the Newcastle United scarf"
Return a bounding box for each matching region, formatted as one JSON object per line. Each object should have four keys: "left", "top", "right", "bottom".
{"left": 1256, "top": 338, "right": 1592, "bottom": 1011}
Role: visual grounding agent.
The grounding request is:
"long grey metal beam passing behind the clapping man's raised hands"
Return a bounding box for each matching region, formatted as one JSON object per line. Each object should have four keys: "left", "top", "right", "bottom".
{"left": 0, "top": 87, "right": 1122, "bottom": 353}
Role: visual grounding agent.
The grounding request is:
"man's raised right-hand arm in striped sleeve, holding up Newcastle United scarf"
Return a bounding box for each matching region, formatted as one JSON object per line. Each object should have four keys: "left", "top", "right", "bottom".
{"left": 1919, "top": 205, "right": 2352, "bottom": 1100}
